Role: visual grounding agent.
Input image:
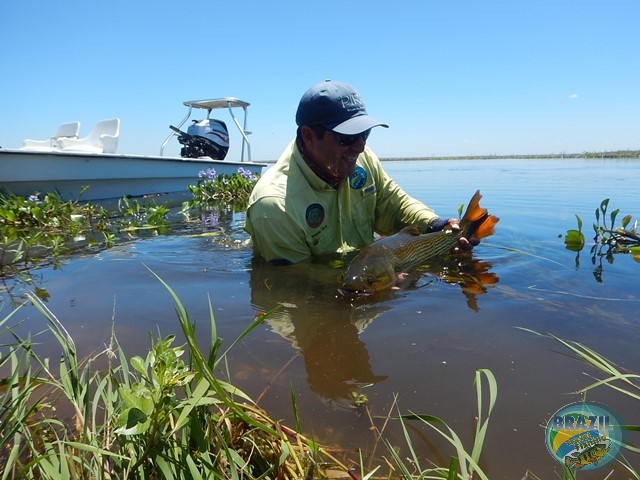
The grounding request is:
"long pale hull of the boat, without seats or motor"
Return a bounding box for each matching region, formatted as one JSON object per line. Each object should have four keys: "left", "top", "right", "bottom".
{"left": 0, "top": 149, "right": 265, "bottom": 201}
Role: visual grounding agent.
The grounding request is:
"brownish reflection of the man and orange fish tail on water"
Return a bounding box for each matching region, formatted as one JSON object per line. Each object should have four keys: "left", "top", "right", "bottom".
{"left": 251, "top": 256, "right": 498, "bottom": 407}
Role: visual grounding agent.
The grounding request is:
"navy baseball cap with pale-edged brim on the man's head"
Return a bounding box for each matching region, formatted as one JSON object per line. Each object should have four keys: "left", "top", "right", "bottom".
{"left": 296, "top": 80, "right": 389, "bottom": 135}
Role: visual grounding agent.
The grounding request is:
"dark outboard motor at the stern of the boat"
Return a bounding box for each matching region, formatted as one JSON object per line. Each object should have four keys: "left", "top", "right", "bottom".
{"left": 170, "top": 118, "right": 229, "bottom": 160}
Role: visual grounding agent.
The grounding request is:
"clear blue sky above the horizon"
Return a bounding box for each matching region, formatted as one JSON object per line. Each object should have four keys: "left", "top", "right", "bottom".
{"left": 0, "top": 0, "right": 640, "bottom": 160}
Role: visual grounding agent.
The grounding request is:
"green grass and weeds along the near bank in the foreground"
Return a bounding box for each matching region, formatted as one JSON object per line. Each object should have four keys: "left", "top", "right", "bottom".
{"left": 0, "top": 282, "right": 640, "bottom": 480}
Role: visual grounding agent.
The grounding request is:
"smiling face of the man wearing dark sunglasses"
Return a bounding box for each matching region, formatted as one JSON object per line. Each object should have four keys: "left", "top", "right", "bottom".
{"left": 302, "top": 127, "right": 368, "bottom": 183}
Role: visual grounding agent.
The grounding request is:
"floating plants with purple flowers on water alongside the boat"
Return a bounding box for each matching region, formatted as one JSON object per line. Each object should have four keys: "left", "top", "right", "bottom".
{"left": 0, "top": 167, "right": 258, "bottom": 277}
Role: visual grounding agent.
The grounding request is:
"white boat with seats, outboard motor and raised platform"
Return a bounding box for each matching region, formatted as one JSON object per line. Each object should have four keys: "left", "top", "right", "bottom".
{"left": 0, "top": 97, "right": 265, "bottom": 201}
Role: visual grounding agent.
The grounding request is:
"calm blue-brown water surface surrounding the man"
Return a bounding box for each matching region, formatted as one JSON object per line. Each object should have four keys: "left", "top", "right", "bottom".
{"left": 0, "top": 159, "right": 640, "bottom": 479}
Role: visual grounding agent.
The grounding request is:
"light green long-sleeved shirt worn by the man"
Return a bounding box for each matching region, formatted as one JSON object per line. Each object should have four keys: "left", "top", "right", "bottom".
{"left": 245, "top": 141, "right": 437, "bottom": 263}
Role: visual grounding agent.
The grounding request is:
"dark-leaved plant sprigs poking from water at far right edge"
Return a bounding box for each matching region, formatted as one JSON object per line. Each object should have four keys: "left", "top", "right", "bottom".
{"left": 564, "top": 198, "right": 640, "bottom": 282}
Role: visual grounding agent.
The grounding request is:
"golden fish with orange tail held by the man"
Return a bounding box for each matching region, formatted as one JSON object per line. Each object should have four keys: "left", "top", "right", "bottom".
{"left": 341, "top": 190, "right": 499, "bottom": 293}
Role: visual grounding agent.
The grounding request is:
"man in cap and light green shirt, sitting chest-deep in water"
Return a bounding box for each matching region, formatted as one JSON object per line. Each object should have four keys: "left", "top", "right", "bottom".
{"left": 245, "top": 80, "right": 477, "bottom": 264}
